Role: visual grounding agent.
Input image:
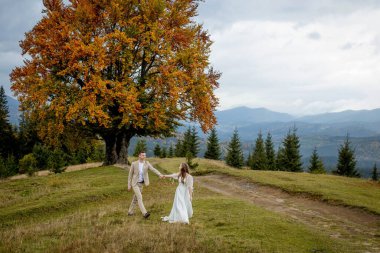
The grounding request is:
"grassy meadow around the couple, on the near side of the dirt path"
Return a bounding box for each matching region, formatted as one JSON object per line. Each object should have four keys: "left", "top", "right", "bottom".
{"left": 0, "top": 159, "right": 374, "bottom": 252}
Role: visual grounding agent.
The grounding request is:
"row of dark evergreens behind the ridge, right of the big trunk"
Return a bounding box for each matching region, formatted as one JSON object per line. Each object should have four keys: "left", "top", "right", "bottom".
{"left": 135, "top": 124, "right": 378, "bottom": 180}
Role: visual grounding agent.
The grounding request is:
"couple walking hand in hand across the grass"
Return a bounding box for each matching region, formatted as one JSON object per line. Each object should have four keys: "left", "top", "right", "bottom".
{"left": 128, "top": 152, "right": 193, "bottom": 223}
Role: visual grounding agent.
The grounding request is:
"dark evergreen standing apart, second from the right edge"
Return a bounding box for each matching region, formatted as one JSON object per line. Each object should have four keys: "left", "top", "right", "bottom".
{"left": 335, "top": 135, "right": 360, "bottom": 177}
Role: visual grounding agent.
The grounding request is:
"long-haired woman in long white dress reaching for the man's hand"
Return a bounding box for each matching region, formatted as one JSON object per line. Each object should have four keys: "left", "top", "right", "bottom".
{"left": 162, "top": 163, "right": 193, "bottom": 224}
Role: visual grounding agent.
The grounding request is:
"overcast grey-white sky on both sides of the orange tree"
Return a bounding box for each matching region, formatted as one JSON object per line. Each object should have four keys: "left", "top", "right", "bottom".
{"left": 0, "top": 0, "right": 380, "bottom": 115}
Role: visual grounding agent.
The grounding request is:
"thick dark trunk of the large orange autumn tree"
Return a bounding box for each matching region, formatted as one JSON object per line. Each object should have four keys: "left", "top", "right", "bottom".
{"left": 103, "top": 132, "right": 133, "bottom": 165}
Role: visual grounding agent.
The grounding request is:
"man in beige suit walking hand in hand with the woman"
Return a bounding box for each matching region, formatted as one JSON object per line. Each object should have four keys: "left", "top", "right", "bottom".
{"left": 128, "top": 151, "right": 163, "bottom": 219}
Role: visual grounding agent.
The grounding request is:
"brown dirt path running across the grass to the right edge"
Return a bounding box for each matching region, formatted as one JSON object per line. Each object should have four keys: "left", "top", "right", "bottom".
{"left": 196, "top": 175, "right": 380, "bottom": 252}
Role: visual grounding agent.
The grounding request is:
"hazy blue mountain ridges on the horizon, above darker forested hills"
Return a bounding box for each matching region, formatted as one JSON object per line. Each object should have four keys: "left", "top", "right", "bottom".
{"left": 215, "top": 107, "right": 380, "bottom": 140}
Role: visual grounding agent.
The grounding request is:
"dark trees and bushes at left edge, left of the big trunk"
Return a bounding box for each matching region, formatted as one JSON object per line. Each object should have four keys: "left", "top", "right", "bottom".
{"left": 0, "top": 86, "right": 104, "bottom": 178}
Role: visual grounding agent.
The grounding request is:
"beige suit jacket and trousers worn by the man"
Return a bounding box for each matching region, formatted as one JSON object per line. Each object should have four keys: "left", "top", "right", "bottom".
{"left": 128, "top": 160, "right": 162, "bottom": 214}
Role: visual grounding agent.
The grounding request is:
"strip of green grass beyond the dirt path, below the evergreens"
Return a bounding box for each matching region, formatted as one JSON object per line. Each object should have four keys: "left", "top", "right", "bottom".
{"left": 159, "top": 158, "right": 380, "bottom": 214}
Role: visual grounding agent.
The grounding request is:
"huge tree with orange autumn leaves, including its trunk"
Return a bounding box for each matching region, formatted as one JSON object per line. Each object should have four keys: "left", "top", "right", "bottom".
{"left": 11, "top": 0, "right": 220, "bottom": 164}
